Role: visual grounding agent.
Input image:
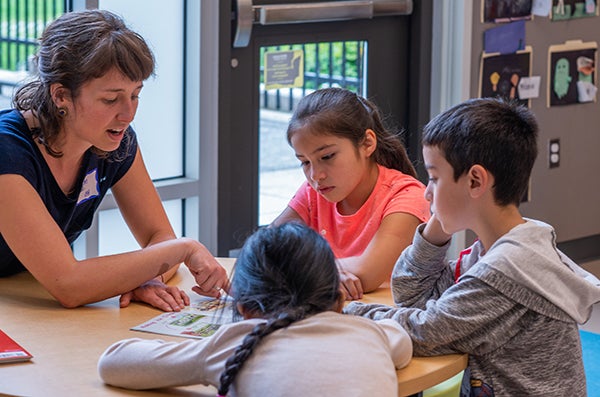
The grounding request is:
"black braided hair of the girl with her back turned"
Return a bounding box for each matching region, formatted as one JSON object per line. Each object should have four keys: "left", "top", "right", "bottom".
{"left": 219, "top": 222, "right": 341, "bottom": 396}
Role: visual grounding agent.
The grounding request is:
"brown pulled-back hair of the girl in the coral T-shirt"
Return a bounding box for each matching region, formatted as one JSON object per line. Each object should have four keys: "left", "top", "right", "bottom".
{"left": 287, "top": 88, "right": 417, "bottom": 177}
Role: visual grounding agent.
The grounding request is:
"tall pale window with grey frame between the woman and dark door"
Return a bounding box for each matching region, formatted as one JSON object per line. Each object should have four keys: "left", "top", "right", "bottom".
{"left": 74, "top": 0, "right": 209, "bottom": 258}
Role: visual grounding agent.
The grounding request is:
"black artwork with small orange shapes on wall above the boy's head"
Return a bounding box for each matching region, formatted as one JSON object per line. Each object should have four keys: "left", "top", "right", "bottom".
{"left": 479, "top": 47, "right": 531, "bottom": 106}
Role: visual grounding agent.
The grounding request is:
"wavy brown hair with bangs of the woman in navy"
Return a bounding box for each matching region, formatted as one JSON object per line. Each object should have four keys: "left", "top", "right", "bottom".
{"left": 13, "top": 10, "right": 155, "bottom": 157}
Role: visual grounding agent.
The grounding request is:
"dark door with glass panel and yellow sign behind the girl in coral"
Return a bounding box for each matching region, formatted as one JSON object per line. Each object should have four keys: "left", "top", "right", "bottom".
{"left": 213, "top": 0, "right": 433, "bottom": 255}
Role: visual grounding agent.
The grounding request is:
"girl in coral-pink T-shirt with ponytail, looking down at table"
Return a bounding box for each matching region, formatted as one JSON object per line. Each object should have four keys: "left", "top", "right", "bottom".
{"left": 272, "top": 88, "right": 430, "bottom": 300}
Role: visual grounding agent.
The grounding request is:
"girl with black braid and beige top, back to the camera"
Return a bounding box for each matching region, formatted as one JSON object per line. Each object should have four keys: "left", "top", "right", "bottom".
{"left": 98, "top": 222, "right": 412, "bottom": 397}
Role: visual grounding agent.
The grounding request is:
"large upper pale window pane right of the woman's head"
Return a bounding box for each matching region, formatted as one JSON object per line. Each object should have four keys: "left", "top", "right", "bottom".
{"left": 99, "top": 0, "right": 185, "bottom": 180}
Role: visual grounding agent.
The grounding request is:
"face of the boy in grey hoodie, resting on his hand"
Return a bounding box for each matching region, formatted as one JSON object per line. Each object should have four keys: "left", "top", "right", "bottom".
{"left": 423, "top": 146, "right": 469, "bottom": 234}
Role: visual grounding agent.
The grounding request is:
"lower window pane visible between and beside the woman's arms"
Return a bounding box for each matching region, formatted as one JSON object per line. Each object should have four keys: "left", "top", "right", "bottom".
{"left": 98, "top": 200, "right": 183, "bottom": 255}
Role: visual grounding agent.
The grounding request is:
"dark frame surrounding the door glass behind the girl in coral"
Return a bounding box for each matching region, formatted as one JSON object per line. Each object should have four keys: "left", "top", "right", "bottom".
{"left": 213, "top": 0, "right": 434, "bottom": 256}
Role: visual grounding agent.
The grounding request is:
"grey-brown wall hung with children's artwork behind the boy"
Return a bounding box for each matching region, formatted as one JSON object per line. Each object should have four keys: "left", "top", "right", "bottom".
{"left": 468, "top": 0, "right": 600, "bottom": 246}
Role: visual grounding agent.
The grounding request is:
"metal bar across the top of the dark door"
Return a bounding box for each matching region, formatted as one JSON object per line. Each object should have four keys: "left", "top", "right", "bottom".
{"left": 233, "top": 0, "right": 413, "bottom": 48}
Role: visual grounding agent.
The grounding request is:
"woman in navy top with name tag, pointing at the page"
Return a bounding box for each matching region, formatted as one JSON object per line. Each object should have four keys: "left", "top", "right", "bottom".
{"left": 0, "top": 10, "right": 228, "bottom": 311}
